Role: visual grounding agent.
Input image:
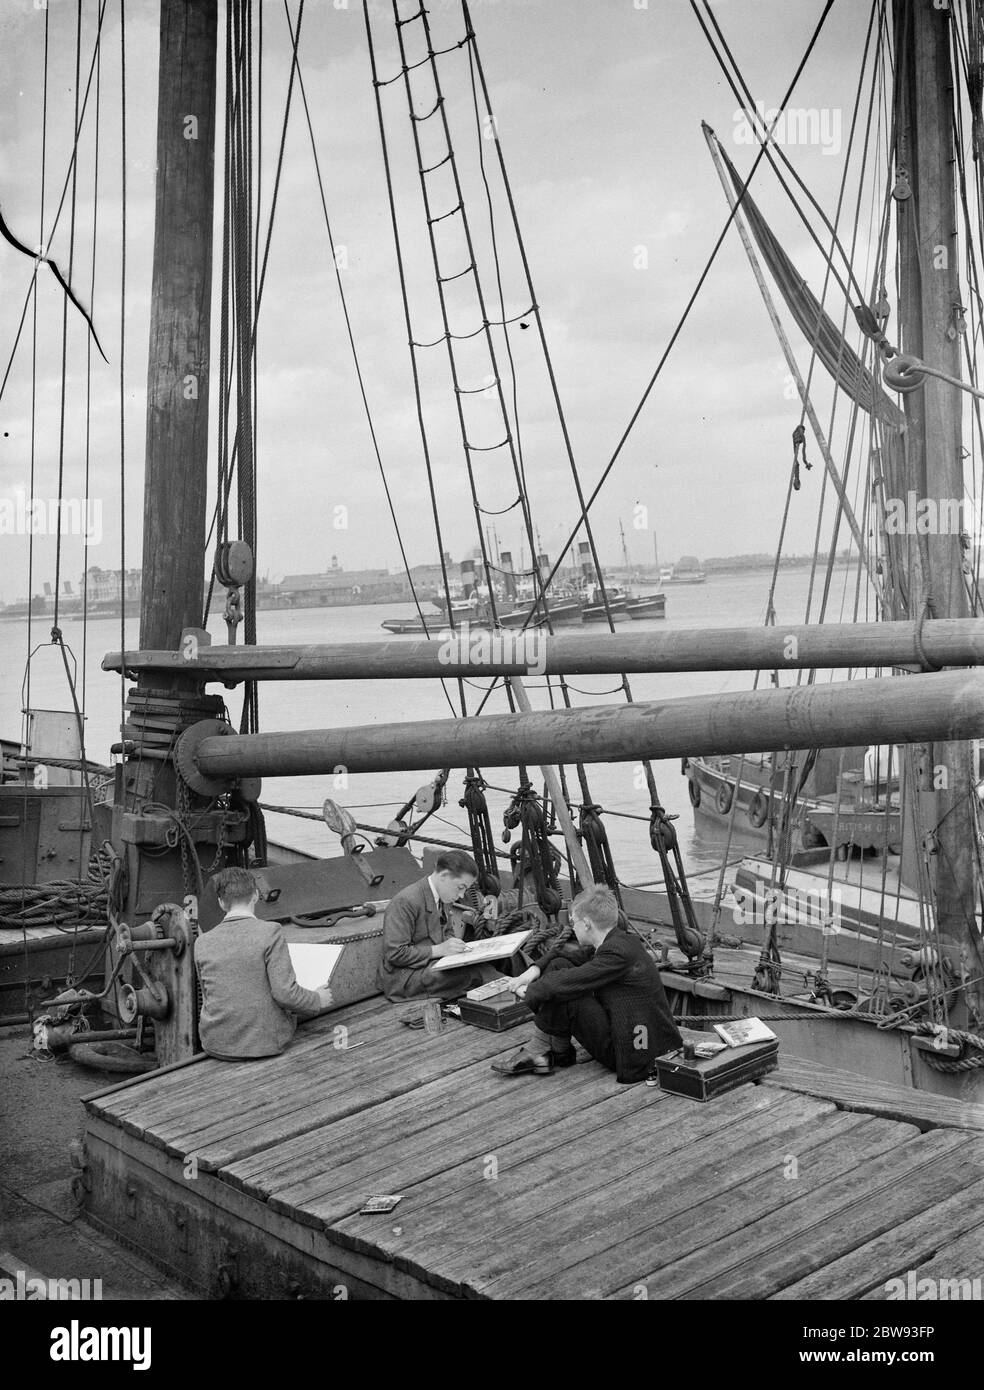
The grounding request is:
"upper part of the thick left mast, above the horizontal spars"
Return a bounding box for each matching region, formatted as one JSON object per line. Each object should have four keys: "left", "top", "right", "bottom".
{"left": 140, "top": 0, "right": 217, "bottom": 648}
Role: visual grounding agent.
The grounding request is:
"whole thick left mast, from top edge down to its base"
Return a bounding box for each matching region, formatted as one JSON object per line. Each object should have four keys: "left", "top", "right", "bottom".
{"left": 111, "top": 0, "right": 219, "bottom": 1066}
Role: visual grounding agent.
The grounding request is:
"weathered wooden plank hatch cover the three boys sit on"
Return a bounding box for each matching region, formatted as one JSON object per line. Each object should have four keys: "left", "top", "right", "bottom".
{"left": 85, "top": 999, "right": 984, "bottom": 1300}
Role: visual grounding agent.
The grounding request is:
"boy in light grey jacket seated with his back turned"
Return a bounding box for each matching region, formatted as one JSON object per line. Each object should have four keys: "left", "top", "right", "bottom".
{"left": 195, "top": 869, "right": 332, "bottom": 1061}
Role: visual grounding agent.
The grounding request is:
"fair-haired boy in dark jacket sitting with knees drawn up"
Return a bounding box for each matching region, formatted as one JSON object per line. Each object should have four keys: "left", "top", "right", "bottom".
{"left": 492, "top": 887, "right": 681, "bottom": 1083}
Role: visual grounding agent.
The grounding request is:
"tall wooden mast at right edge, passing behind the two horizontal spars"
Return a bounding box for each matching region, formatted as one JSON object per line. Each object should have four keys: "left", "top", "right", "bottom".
{"left": 894, "top": 0, "right": 984, "bottom": 1026}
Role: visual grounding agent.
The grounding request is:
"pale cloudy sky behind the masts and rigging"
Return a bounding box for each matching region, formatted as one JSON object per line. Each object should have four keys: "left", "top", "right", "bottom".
{"left": 0, "top": 0, "right": 884, "bottom": 602}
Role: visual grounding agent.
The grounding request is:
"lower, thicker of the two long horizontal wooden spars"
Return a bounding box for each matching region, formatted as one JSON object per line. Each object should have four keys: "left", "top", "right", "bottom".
{"left": 179, "top": 671, "right": 984, "bottom": 778}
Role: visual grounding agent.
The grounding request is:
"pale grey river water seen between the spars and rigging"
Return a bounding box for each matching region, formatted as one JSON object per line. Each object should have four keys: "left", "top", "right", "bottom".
{"left": 0, "top": 569, "right": 853, "bottom": 891}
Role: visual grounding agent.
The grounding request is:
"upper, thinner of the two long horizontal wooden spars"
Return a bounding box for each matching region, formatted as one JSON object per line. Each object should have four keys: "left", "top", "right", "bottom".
{"left": 103, "top": 619, "right": 984, "bottom": 685}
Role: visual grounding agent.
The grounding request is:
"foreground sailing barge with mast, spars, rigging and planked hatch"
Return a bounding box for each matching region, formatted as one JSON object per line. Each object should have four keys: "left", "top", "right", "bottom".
{"left": 6, "top": 0, "right": 984, "bottom": 1298}
